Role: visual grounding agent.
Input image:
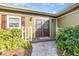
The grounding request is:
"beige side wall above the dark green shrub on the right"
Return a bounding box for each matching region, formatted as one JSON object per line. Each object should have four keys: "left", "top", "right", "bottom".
{"left": 58, "top": 10, "right": 79, "bottom": 28}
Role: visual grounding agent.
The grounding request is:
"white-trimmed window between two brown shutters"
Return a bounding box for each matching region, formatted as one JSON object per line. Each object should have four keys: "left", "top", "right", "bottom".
{"left": 7, "top": 16, "right": 21, "bottom": 28}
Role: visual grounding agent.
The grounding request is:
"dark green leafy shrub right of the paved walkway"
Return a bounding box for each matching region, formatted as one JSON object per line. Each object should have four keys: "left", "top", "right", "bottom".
{"left": 56, "top": 25, "right": 79, "bottom": 55}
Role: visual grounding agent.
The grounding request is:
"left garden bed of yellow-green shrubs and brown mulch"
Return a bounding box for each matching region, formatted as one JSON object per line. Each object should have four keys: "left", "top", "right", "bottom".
{"left": 0, "top": 29, "right": 32, "bottom": 56}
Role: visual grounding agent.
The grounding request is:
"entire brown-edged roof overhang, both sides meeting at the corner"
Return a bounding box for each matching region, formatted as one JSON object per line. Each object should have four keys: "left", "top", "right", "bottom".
{"left": 0, "top": 3, "right": 79, "bottom": 18}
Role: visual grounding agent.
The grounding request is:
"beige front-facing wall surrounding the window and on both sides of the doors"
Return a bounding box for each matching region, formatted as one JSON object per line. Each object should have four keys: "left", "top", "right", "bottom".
{"left": 0, "top": 11, "right": 56, "bottom": 38}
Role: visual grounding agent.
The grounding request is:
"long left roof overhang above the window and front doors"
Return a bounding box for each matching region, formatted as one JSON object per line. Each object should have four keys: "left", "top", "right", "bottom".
{"left": 0, "top": 5, "right": 54, "bottom": 17}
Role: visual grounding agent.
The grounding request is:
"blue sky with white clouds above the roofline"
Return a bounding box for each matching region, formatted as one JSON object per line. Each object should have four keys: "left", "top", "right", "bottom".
{"left": 2, "top": 3, "right": 71, "bottom": 14}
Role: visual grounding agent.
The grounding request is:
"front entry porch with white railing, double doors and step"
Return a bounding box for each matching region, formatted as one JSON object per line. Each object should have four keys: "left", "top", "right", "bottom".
{"left": 22, "top": 18, "right": 56, "bottom": 42}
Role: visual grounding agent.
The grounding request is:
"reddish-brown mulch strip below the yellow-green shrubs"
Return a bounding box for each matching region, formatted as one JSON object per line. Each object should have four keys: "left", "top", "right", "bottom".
{"left": 0, "top": 47, "right": 32, "bottom": 56}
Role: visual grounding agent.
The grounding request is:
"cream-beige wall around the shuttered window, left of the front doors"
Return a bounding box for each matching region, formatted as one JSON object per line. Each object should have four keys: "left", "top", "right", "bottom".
{"left": 0, "top": 12, "right": 35, "bottom": 38}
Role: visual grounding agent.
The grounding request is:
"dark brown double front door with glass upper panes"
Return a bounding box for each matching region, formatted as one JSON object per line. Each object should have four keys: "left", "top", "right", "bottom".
{"left": 36, "top": 20, "right": 50, "bottom": 37}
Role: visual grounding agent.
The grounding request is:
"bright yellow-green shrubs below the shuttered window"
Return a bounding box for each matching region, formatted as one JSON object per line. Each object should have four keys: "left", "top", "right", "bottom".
{"left": 0, "top": 29, "right": 31, "bottom": 50}
